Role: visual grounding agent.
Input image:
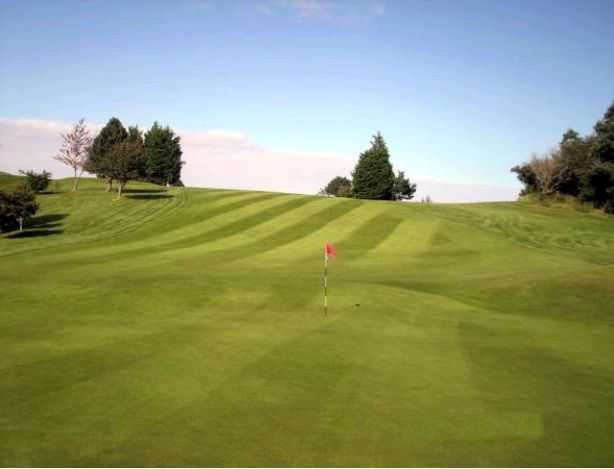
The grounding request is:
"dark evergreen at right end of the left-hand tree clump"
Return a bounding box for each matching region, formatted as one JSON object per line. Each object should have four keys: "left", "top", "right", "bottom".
{"left": 144, "top": 122, "right": 183, "bottom": 185}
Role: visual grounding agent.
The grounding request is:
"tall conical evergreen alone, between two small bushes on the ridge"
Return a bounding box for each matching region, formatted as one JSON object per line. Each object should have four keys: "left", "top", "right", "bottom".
{"left": 352, "top": 132, "right": 394, "bottom": 200}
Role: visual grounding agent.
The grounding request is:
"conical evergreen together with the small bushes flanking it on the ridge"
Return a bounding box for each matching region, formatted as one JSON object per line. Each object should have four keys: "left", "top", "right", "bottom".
{"left": 320, "top": 132, "right": 416, "bottom": 200}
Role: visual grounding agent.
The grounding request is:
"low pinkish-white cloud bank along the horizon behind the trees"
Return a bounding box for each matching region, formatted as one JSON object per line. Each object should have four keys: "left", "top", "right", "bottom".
{"left": 0, "top": 119, "right": 517, "bottom": 202}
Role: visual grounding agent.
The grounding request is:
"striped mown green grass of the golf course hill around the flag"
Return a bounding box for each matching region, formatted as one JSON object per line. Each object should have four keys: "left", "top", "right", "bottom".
{"left": 0, "top": 176, "right": 614, "bottom": 466}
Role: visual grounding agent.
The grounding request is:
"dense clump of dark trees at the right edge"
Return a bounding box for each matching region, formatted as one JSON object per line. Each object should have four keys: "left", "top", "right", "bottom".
{"left": 511, "top": 102, "right": 614, "bottom": 213}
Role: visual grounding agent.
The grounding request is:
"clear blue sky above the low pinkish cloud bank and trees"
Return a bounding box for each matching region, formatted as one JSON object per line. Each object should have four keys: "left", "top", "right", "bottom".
{"left": 0, "top": 0, "right": 614, "bottom": 185}
